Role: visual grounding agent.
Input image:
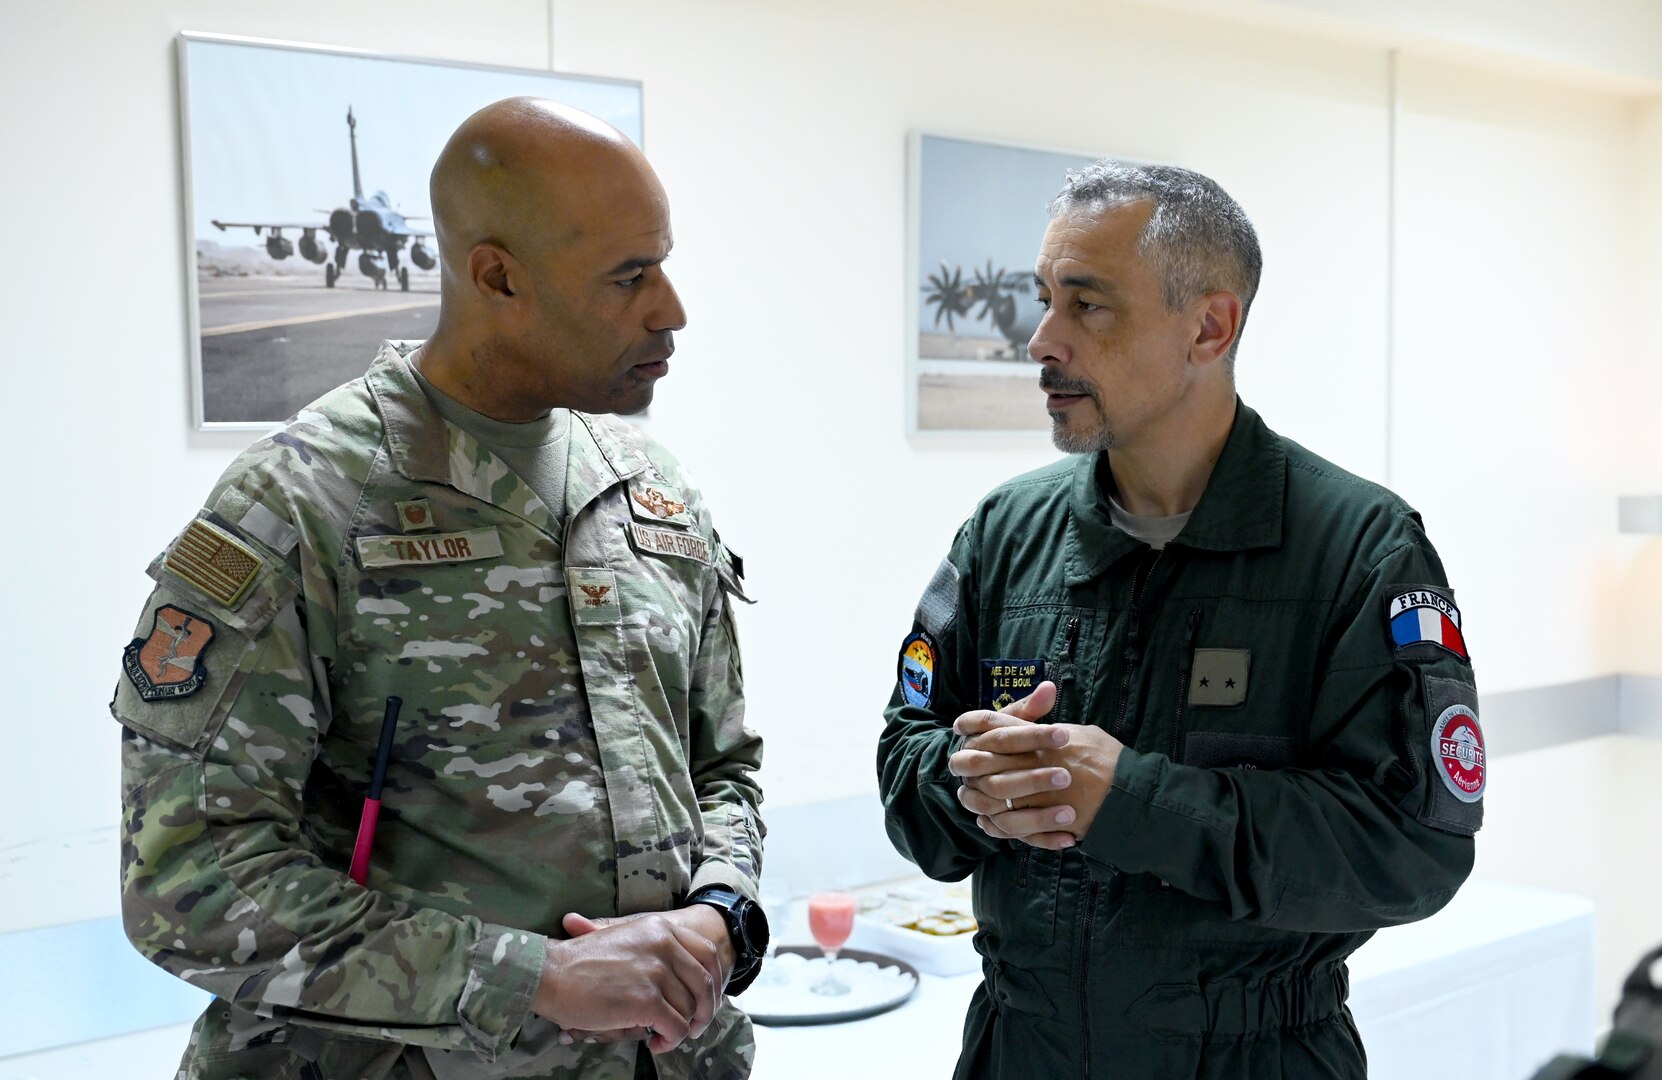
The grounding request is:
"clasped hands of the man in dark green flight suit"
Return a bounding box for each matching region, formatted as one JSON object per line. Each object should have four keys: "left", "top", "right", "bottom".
{"left": 947, "top": 681, "right": 1124, "bottom": 851}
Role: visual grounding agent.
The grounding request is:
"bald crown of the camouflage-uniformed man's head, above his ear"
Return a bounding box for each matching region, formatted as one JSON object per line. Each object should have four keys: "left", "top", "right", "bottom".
{"left": 430, "top": 98, "right": 656, "bottom": 277}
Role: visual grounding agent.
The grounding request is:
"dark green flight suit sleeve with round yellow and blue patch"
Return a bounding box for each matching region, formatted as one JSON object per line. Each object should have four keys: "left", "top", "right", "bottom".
{"left": 878, "top": 520, "right": 1002, "bottom": 881}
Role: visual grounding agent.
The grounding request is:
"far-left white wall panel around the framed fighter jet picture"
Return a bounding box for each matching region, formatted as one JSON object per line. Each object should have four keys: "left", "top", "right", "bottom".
{"left": 0, "top": 0, "right": 548, "bottom": 850}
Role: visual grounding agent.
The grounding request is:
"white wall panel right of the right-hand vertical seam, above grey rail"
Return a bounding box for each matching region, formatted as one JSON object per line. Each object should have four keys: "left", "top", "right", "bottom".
{"left": 1391, "top": 60, "right": 1635, "bottom": 691}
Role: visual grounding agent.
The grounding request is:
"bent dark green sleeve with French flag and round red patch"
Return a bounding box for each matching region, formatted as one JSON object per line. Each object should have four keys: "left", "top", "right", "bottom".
{"left": 1082, "top": 515, "right": 1484, "bottom": 930}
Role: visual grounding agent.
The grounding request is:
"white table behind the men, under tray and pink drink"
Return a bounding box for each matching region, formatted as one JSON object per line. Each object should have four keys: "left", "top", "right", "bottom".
{"left": 755, "top": 881, "right": 1594, "bottom": 1080}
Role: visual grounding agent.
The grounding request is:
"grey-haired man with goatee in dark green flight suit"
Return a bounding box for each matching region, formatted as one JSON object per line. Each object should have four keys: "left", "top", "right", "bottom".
{"left": 878, "top": 161, "right": 1484, "bottom": 1080}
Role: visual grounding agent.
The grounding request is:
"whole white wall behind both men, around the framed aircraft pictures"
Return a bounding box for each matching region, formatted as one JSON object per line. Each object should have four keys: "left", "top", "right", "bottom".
{"left": 0, "top": 0, "right": 1662, "bottom": 1030}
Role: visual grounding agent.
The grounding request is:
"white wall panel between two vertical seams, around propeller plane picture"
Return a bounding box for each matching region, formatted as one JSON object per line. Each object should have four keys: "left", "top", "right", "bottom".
{"left": 555, "top": 0, "right": 1386, "bottom": 803}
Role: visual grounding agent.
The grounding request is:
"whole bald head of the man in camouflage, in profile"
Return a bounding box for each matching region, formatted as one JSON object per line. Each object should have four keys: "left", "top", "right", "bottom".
{"left": 416, "top": 98, "right": 686, "bottom": 422}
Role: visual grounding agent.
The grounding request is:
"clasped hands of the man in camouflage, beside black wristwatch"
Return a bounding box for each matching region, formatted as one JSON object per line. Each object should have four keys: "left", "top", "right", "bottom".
{"left": 532, "top": 904, "right": 733, "bottom": 1053}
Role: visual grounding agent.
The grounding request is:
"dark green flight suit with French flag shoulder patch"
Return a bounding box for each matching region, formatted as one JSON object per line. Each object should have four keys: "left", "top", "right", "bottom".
{"left": 878, "top": 404, "right": 1484, "bottom": 1080}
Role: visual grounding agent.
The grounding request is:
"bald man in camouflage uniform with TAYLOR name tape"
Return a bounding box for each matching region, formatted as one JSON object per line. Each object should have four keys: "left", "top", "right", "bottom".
{"left": 111, "top": 98, "right": 765, "bottom": 1080}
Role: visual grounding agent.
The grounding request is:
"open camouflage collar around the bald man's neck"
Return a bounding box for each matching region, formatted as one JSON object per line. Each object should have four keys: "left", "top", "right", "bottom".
{"left": 364, "top": 341, "right": 647, "bottom": 540}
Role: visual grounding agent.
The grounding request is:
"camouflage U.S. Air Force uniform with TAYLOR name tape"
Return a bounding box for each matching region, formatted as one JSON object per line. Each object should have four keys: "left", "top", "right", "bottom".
{"left": 111, "top": 344, "right": 763, "bottom": 1080}
